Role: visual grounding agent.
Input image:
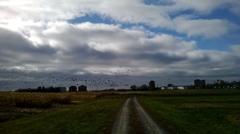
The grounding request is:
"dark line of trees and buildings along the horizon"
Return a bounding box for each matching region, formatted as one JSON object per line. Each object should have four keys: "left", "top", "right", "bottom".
{"left": 16, "top": 79, "right": 240, "bottom": 92}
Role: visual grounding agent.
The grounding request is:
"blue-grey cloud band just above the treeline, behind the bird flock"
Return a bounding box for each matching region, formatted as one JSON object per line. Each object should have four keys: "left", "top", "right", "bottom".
{"left": 0, "top": 69, "right": 239, "bottom": 91}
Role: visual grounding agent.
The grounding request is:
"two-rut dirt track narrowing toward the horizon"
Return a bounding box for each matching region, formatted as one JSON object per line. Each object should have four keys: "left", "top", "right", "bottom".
{"left": 112, "top": 97, "right": 167, "bottom": 134}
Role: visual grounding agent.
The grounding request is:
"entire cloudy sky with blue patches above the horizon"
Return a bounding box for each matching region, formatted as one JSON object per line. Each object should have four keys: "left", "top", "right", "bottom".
{"left": 0, "top": 0, "right": 240, "bottom": 89}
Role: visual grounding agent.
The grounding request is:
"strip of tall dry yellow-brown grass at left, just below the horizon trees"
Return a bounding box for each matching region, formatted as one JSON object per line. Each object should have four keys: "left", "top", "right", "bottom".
{"left": 0, "top": 92, "right": 100, "bottom": 108}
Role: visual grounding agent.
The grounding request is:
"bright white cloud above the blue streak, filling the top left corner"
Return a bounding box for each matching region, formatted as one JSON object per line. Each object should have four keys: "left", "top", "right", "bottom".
{"left": 0, "top": 0, "right": 169, "bottom": 26}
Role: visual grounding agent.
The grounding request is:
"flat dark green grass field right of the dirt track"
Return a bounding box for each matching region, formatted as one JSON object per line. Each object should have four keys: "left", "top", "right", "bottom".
{"left": 140, "top": 95, "right": 240, "bottom": 134}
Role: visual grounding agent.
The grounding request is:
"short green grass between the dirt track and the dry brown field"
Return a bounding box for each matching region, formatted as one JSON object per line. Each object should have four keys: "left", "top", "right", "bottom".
{"left": 0, "top": 97, "right": 124, "bottom": 134}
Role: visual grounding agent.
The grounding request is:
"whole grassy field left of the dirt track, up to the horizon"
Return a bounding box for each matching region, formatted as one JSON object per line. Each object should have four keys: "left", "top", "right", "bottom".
{"left": 0, "top": 94, "right": 125, "bottom": 134}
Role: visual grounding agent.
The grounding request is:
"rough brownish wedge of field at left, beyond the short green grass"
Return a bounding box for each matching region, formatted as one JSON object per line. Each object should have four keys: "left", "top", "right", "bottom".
{"left": 0, "top": 92, "right": 97, "bottom": 123}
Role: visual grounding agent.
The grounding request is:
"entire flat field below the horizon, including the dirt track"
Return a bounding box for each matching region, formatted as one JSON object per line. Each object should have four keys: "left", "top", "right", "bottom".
{"left": 0, "top": 90, "right": 240, "bottom": 134}
